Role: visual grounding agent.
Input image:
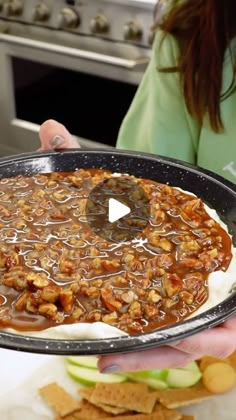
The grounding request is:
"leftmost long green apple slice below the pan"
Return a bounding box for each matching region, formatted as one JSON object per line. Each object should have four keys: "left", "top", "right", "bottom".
{"left": 66, "top": 363, "right": 127, "bottom": 386}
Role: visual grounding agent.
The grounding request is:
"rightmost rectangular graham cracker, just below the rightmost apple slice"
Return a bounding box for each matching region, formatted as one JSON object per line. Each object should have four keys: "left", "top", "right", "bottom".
{"left": 155, "top": 384, "right": 214, "bottom": 408}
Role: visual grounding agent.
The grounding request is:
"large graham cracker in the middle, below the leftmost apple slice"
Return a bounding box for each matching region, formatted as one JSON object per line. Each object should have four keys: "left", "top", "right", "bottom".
{"left": 91, "top": 382, "right": 157, "bottom": 414}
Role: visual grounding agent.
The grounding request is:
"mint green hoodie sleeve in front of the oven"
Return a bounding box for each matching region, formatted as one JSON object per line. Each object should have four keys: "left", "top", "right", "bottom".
{"left": 117, "top": 30, "right": 200, "bottom": 164}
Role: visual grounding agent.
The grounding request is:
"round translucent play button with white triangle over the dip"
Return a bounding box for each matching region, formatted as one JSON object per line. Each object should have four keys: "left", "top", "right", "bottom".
{"left": 85, "top": 176, "right": 150, "bottom": 243}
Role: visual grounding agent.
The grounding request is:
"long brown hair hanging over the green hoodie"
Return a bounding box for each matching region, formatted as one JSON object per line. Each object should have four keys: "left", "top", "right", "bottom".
{"left": 156, "top": 0, "right": 236, "bottom": 132}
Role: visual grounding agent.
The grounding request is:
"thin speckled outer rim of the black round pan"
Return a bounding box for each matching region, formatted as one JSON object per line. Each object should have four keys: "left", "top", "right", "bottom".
{"left": 0, "top": 149, "right": 236, "bottom": 355}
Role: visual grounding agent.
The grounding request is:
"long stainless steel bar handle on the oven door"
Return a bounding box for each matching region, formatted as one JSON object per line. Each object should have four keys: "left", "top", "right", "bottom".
{"left": 0, "top": 33, "right": 149, "bottom": 70}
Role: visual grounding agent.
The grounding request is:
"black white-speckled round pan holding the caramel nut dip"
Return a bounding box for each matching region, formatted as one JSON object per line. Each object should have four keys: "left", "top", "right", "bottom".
{"left": 0, "top": 149, "right": 236, "bottom": 355}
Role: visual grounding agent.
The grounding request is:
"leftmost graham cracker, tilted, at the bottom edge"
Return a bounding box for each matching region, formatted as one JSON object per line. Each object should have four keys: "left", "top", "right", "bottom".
{"left": 39, "top": 382, "right": 80, "bottom": 417}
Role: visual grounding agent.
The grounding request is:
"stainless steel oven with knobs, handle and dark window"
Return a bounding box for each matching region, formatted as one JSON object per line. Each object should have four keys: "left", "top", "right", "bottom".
{"left": 0, "top": 0, "right": 156, "bottom": 155}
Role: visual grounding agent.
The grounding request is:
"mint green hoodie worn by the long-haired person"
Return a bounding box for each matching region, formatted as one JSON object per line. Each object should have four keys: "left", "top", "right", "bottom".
{"left": 117, "top": 30, "right": 236, "bottom": 184}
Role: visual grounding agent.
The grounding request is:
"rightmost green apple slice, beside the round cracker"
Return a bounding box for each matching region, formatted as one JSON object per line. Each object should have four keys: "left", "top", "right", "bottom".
{"left": 166, "top": 369, "right": 202, "bottom": 388}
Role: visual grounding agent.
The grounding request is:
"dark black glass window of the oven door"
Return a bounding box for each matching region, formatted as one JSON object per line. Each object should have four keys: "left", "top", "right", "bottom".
{"left": 12, "top": 57, "right": 137, "bottom": 146}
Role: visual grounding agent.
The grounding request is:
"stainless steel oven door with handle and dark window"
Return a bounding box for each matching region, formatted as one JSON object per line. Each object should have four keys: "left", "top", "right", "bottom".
{"left": 0, "top": 25, "right": 149, "bottom": 156}
